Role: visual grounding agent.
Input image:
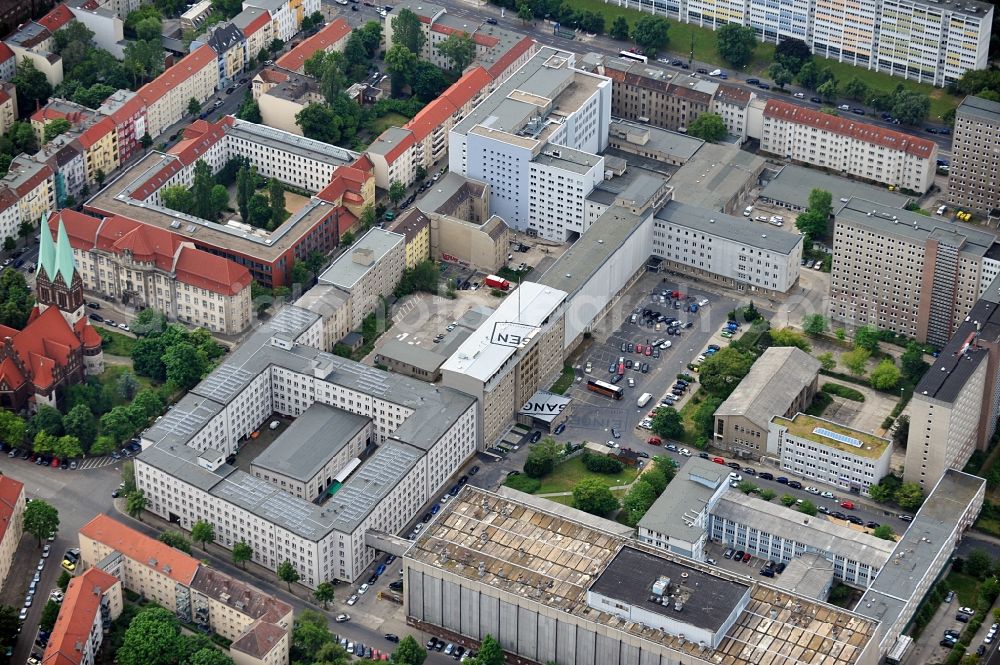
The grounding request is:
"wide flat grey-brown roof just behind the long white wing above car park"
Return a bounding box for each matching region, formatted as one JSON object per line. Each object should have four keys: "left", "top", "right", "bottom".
{"left": 670, "top": 143, "right": 766, "bottom": 210}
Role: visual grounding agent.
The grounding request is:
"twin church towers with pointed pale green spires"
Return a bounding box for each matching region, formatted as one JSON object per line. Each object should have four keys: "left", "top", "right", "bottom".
{"left": 35, "top": 215, "right": 85, "bottom": 326}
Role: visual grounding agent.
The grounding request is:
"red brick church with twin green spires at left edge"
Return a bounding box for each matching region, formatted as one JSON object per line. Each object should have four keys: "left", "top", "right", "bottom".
{"left": 0, "top": 214, "right": 104, "bottom": 412}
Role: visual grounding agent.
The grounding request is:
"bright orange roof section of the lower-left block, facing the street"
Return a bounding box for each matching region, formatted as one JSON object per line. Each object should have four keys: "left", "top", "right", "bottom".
{"left": 80, "top": 515, "right": 198, "bottom": 586}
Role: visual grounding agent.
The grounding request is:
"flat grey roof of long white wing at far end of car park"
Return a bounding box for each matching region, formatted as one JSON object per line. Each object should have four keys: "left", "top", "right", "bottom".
{"left": 656, "top": 200, "right": 802, "bottom": 254}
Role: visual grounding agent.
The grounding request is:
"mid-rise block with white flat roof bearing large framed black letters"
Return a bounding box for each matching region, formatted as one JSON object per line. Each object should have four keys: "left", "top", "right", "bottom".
{"left": 441, "top": 282, "right": 566, "bottom": 446}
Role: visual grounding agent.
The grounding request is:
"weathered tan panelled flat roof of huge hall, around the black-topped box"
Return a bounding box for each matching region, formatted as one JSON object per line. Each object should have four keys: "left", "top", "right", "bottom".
{"left": 406, "top": 486, "right": 877, "bottom": 665}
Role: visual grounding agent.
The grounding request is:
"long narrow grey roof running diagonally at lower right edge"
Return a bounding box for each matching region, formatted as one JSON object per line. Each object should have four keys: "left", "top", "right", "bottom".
{"left": 854, "top": 469, "right": 986, "bottom": 639}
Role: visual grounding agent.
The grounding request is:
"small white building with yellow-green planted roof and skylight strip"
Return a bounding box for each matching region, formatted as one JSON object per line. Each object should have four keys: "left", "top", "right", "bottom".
{"left": 767, "top": 413, "right": 892, "bottom": 496}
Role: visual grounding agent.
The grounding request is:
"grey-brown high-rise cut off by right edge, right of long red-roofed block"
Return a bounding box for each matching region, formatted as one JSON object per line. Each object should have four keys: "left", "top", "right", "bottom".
{"left": 948, "top": 96, "right": 1000, "bottom": 214}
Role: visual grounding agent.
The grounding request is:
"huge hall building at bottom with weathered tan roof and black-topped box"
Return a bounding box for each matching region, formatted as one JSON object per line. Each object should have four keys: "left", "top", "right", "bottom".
{"left": 403, "top": 487, "right": 879, "bottom": 665}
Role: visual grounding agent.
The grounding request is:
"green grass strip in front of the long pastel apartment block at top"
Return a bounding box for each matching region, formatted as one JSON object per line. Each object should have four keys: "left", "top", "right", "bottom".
{"left": 573, "top": 0, "right": 961, "bottom": 118}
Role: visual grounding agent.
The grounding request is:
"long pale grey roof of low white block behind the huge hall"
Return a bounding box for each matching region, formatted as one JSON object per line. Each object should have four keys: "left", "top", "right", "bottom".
{"left": 712, "top": 490, "right": 894, "bottom": 568}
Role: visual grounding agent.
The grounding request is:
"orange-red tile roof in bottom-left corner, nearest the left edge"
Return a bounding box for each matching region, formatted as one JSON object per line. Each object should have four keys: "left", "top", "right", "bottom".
{"left": 42, "top": 568, "right": 118, "bottom": 665}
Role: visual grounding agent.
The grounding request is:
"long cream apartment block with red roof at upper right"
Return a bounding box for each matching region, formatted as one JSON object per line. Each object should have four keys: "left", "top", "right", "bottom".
{"left": 754, "top": 99, "right": 937, "bottom": 194}
